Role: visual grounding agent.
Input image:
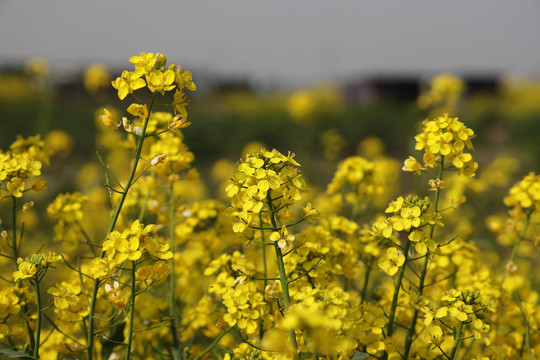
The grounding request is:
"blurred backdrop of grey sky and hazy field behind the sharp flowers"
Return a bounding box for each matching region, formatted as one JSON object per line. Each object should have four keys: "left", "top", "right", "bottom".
{"left": 0, "top": 0, "right": 540, "bottom": 188}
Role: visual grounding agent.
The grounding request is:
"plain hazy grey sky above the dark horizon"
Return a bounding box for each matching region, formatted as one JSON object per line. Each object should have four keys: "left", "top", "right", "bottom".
{"left": 0, "top": 0, "right": 540, "bottom": 83}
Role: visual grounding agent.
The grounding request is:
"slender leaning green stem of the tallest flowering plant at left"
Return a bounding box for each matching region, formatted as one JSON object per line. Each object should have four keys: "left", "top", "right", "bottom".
{"left": 87, "top": 93, "right": 156, "bottom": 360}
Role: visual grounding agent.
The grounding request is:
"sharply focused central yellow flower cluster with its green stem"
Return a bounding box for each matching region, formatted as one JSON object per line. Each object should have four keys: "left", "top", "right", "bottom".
{"left": 226, "top": 149, "right": 314, "bottom": 349}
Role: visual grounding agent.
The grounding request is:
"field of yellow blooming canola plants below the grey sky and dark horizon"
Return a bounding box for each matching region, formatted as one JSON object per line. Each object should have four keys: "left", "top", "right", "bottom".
{"left": 0, "top": 53, "right": 540, "bottom": 360}
